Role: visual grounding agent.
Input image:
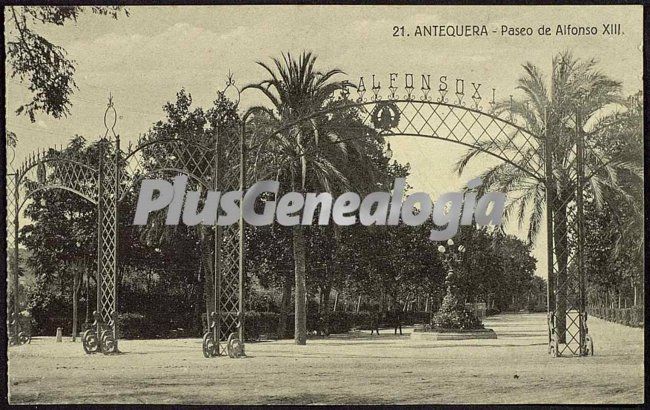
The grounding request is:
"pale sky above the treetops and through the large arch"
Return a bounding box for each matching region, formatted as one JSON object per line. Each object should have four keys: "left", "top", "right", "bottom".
{"left": 5, "top": 6, "right": 643, "bottom": 277}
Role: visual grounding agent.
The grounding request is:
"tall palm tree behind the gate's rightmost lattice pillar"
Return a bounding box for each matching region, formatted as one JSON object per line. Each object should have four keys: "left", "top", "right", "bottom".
{"left": 455, "top": 52, "right": 631, "bottom": 343}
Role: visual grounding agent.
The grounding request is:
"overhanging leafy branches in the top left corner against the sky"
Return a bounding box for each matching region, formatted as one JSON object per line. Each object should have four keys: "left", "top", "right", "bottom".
{"left": 5, "top": 6, "right": 128, "bottom": 122}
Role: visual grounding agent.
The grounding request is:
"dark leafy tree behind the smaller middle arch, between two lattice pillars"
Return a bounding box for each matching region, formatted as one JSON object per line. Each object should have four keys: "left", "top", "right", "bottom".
{"left": 130, "top": 90, "right": 239, "bottom": 334}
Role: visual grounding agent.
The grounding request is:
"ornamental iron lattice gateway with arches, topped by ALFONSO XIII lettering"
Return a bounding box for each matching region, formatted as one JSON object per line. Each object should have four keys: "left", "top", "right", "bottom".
{"left": 7, "top": 74, "right": 608, "bottom": 357}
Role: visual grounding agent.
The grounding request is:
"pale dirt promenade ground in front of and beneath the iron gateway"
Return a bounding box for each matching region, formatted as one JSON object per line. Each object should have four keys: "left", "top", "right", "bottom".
{"left": 9, "top": 314, "right": 643, "bottom": 404}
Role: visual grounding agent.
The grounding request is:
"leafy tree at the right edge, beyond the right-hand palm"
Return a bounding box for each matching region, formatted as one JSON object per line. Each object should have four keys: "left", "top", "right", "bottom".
{"left": 584, "top": 93, "right": 644, "bottom": 304}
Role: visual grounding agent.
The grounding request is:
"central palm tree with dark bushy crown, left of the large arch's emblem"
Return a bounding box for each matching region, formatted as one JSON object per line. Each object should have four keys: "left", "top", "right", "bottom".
{"left": 242, "top": 52, "right": 369, "bottom": 345}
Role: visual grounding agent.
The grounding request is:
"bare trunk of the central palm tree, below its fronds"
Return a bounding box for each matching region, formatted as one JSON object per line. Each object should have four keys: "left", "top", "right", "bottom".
{"left": 292, "top": 225, "right": 307, "bottom": 345}
